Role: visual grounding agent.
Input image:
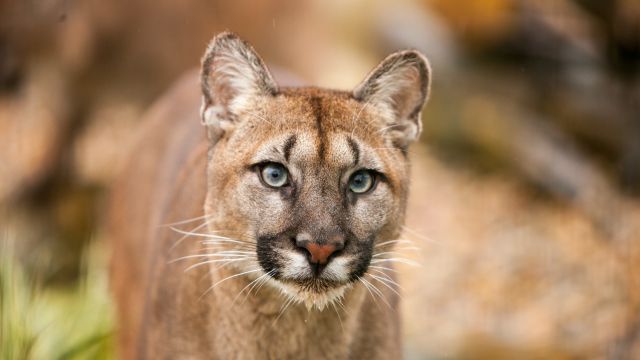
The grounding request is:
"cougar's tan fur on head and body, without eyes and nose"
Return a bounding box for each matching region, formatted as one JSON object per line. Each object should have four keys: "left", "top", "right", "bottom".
{"left": 110, "top": 33, "right": 429, "bottom": 359}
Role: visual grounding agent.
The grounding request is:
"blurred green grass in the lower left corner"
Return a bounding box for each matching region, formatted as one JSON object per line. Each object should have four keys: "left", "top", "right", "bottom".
{"left": 0, "top": 239, "right": 114, "bottom": 360}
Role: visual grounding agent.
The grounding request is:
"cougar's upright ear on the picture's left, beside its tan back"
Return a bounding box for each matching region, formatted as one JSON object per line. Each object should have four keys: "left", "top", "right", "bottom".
{"left": 200, "top": 32, "right": 278, "bottom": 137}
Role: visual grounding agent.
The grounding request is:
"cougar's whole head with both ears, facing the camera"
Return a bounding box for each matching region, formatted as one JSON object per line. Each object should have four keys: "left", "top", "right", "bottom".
{"left": 202, "top": 34, "right": 428, "bottom": 308}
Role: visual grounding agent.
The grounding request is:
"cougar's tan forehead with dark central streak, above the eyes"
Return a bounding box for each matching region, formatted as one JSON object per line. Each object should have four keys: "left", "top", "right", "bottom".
{"left": 236, "top": 88, "right": 385, "bottom": 168}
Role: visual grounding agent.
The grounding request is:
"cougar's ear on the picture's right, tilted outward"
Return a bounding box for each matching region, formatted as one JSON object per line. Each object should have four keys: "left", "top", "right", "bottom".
{"left": 353, "top": 50, "right": 431, "bottom": 148}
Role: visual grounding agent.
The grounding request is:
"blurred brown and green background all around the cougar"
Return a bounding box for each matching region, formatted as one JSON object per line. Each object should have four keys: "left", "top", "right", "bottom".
{"left": 0, "top": 0, "right": 640, "bottom": 359}
